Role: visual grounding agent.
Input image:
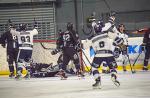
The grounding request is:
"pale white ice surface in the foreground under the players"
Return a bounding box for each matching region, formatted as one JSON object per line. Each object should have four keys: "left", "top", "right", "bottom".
{"left": 0, "top": 72, "right": 150, "bottom": 98}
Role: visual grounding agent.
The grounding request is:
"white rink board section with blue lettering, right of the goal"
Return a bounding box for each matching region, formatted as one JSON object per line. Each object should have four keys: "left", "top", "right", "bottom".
{"left": 83, "top": 37, "right": 150, "bottom": 70}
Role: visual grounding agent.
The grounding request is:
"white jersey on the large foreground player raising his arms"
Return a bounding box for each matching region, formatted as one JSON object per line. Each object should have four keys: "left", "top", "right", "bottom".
{"left": 88, "top": 23, "right": 120, "bottom": 57}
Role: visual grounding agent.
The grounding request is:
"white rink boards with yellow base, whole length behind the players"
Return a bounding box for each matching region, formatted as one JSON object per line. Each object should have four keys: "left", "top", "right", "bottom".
{"left": 0, "top": 37, "right": 150, "bottom": 74}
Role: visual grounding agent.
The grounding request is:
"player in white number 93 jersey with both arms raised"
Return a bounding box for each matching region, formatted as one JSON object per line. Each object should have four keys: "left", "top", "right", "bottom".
{"left": 11, "top": 24, "right": 38, "bottom": 79}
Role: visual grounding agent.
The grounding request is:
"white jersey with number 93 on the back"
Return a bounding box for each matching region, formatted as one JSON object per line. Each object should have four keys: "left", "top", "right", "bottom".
{"left": 10, "top": 29, "right": 38, "bottom": 50}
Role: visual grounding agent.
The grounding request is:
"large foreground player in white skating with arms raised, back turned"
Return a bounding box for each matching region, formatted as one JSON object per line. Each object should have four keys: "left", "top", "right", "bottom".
{"left": 86, "top": 12, "right": 123, "bottom": 88}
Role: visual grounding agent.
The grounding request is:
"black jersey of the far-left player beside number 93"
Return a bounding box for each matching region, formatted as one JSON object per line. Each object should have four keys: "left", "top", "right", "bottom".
{"left": 1, "top": 31, "right": 18, "bottom": 50}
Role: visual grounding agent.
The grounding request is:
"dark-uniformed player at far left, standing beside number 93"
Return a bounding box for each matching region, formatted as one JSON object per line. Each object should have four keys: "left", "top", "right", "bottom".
{"left": 1, "top": 25, "right": 18, "bottom": 78}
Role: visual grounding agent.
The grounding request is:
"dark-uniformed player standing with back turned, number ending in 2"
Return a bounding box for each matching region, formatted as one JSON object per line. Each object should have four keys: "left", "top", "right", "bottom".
{"left": 56, "top": 22, "right": 83, "bottom": 78}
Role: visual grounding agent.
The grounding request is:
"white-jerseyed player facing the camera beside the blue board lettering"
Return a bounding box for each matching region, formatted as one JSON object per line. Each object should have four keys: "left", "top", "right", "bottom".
{"left": 118, "top": 24, "right": 128, "bottom": 72}
